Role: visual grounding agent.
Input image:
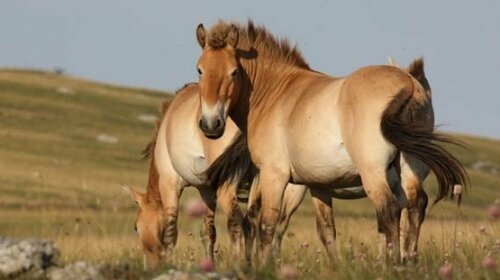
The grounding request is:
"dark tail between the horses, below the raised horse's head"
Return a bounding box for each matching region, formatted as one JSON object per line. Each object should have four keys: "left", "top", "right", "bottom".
{"left": 204, "top": 134, "right": 258, "bottom": 199}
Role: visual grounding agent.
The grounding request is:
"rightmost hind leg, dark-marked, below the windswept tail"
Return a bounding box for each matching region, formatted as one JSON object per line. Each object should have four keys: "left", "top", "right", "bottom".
{"left": 398, "top": 153, "right": 429, "bottom": 262}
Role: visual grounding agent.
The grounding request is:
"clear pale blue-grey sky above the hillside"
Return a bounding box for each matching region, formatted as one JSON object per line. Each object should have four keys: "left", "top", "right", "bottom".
{"left": 0, "top": 0, "right": 500, "bottom": 139}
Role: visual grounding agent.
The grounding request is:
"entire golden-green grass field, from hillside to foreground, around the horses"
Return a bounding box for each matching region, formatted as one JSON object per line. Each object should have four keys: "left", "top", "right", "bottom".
{"left": 0, "top": 70, "right": 500, "bottom": 279}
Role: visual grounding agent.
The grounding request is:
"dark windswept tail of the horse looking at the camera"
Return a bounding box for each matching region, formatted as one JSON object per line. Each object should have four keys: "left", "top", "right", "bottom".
{"left": 380, "top": 59, "right": 469, "bottom": 204}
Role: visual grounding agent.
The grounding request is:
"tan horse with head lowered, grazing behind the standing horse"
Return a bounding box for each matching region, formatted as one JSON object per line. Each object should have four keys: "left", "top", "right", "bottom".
{"left": 124, "top": 83, "right": 360, "bottom": 269}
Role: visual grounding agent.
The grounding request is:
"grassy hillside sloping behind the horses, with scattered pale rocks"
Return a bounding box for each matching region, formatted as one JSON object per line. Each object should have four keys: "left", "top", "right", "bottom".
{"left": 0, "top": 70, "right": 500, "bottom": 278}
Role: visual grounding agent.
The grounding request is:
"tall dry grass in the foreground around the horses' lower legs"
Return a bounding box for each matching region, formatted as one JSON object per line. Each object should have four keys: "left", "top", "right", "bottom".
{"left": 0, "top": 202, "right": 500, "bottom": 279}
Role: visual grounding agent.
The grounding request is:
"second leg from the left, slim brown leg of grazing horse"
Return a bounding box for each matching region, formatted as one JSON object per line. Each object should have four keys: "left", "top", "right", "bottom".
{"left": 198, "top": 187, "right": 217, "bottom": 260}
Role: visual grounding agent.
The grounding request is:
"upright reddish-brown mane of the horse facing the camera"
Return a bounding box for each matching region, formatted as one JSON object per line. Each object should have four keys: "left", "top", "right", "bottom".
{"left": 207, "top": 20, "right": 310, "bottom": 70}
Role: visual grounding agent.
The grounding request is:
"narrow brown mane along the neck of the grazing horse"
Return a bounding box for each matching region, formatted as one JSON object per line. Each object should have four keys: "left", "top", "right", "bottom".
{"left": 141, "top": 83, "right": 194, "bottom": 203}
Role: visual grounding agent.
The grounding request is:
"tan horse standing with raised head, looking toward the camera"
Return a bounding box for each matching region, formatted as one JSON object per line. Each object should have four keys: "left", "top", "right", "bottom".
{"left": 196, "top": 21, "right": 467, "bottom": 262}
